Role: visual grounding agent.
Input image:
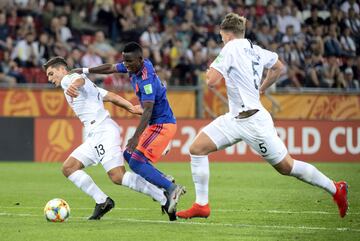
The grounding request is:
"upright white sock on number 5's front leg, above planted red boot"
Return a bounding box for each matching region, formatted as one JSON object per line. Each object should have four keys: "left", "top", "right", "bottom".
{"left": 190, "top": 155, "right": 210, "bottom": 206}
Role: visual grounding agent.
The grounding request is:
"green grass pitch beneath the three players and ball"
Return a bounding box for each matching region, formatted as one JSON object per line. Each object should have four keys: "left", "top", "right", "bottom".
{"left": 0, "top": 162, "right": 360, "bottom": 241}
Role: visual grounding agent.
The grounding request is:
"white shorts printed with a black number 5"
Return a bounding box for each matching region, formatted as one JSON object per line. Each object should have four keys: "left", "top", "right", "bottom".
{"left": 202, "top": 109, "right": 287, "bottom": 165}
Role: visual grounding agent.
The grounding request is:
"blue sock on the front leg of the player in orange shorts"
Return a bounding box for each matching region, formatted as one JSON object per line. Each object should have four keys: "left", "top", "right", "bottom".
{"left": 129, "top": 150, "right": 174, "bottom": 191}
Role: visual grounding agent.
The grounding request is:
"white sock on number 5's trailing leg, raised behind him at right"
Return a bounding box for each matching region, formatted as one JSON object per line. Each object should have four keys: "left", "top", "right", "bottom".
{"left": 290, "top": 160, "right": 336, "bottom": 195}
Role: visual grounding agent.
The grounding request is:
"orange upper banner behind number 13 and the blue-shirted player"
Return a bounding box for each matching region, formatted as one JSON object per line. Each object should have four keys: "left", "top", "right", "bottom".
{"left": 0, "top": 89, "right": 196, "bottom": 118}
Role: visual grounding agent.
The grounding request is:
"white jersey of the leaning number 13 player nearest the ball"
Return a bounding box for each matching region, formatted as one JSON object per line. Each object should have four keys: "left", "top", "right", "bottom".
{"left": 61, "top": 73, "right": 110, "bottom": 134}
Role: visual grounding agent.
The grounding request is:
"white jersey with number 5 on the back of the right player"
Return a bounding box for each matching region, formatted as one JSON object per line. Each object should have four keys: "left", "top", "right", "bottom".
{"left": 210, "top": 39, "right": 278, "bottom": 116}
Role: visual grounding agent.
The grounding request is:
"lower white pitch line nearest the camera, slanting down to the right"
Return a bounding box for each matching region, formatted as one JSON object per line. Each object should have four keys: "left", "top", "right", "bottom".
{"left": 0, "top": 212, "right": 360, "bottom": 232}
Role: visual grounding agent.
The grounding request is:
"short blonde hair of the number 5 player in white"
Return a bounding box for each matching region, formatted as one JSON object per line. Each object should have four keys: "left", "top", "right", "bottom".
{"left": 220, "top": 13, "right": 246, "bottom": 37}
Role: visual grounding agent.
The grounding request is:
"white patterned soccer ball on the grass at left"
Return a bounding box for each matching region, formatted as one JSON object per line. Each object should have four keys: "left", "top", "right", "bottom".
{"left": 44, "top": 198, "right": 70, "bottom": 222}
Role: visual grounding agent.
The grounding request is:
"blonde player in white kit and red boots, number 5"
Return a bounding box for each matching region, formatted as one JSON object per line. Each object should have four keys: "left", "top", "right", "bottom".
{"left": 176, "top": 13, "right": 348, "bottom": 218}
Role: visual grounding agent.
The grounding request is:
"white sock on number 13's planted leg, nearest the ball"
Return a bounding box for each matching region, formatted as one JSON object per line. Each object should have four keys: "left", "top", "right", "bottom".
{"left": 68, "top": 170, "right": 108, "bottom": 203}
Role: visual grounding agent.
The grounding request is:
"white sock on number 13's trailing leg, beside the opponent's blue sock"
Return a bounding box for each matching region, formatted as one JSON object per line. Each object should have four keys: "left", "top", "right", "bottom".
{"left": 122, "top": 172, "right": 166, "bottom": 205}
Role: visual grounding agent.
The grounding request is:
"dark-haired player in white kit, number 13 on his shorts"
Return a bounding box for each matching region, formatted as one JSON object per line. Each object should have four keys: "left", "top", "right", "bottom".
{"left": 44, "top": 57, "right": 168, "bottom": 220}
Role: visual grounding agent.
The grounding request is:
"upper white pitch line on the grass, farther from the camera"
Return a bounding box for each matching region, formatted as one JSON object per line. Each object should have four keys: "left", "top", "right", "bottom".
{"left": 0, "top": 206, "right": 360, "bottom": 215}
